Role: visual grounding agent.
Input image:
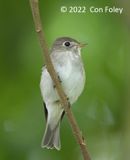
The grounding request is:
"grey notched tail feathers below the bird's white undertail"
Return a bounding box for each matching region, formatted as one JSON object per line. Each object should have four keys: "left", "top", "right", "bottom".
{"left": 42, "top": 122, "right": 61, "bottom": 150}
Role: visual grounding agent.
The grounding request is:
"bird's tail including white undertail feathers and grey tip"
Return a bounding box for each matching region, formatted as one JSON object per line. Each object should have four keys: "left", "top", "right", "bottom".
{"left": 42, "top": 102, "right": 64, "bottom": 150}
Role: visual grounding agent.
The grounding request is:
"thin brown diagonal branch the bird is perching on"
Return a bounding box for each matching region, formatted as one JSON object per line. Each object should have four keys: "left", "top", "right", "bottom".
{"left": 30, "top": 0, "right": 90, "bottom": 160}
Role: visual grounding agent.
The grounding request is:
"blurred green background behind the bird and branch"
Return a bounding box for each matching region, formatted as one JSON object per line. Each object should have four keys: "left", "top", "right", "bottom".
{"left": 0, "top": 0, "right": 130, "bottom": 160}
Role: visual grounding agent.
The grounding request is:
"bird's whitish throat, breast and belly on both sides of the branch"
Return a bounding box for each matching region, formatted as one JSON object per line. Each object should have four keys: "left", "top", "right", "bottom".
{"left": 40, "top": 52, "right": 85, "bottom": 104}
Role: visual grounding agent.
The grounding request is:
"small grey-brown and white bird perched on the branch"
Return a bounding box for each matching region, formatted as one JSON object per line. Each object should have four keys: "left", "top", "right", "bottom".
{"left": 40, "top": 37, "right": 86, "bottom": 150}
